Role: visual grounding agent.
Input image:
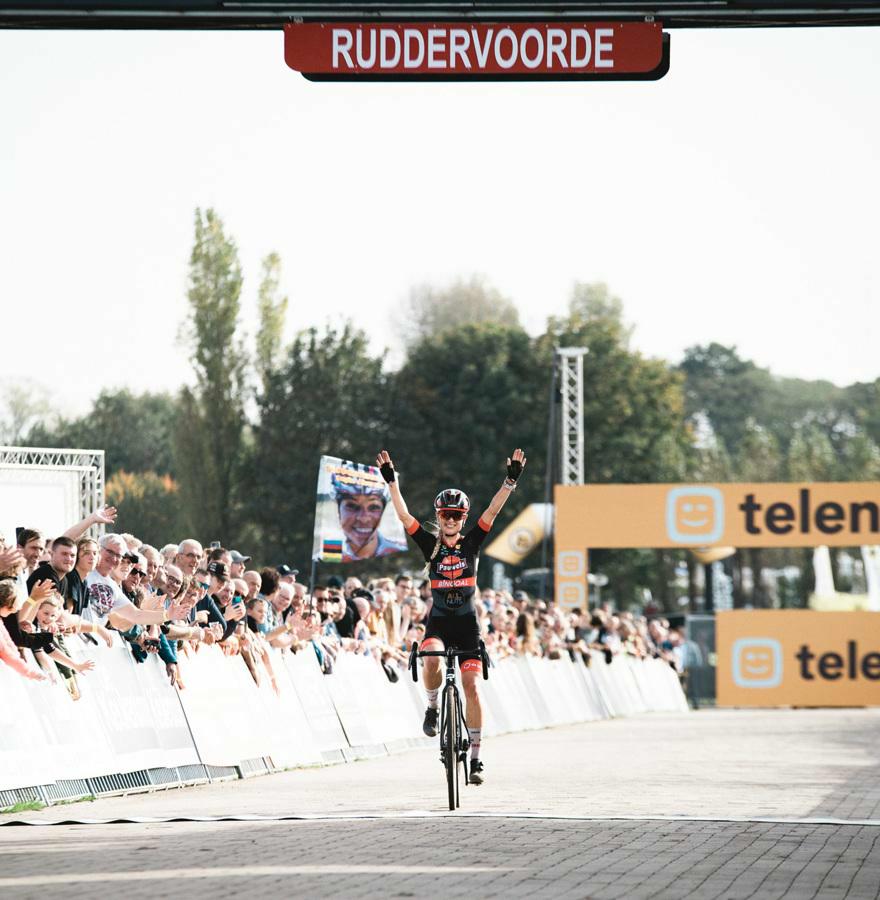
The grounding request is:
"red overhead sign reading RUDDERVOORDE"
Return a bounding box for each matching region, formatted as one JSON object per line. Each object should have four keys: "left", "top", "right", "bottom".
{"left": 284, "top": 22, "right": 663, "bottom": 79}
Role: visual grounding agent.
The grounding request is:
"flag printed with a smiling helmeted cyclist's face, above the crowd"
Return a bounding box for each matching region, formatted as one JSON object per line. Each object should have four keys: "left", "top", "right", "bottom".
{"left": 312, "top": 456, "right": 407, "bottom": 563}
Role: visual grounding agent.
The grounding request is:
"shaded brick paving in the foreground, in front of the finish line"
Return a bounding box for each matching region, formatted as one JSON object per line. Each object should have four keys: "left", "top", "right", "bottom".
{"left": 0, "top": 817, "right": 880, "bottom": 900}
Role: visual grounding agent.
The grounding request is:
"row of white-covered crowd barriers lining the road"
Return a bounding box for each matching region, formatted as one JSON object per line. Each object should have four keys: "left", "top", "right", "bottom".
{"left": 0, "top": 637, "right": 688, "bottom": 807}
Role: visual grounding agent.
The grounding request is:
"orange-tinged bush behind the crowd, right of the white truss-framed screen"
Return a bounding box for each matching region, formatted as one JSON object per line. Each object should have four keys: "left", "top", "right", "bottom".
{"left": 106, "top": 470, "right": 186, "bottom": 547}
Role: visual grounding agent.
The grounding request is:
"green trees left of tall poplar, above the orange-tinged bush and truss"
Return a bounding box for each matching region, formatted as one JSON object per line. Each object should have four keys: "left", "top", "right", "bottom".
{"left": 27, "top": 390, "right": 178, "bottom": 477}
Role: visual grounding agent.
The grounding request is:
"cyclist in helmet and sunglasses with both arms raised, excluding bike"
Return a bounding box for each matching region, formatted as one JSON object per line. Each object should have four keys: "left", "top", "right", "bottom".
{"left": 376, "top": 447, "right": 526, "bottom": 784}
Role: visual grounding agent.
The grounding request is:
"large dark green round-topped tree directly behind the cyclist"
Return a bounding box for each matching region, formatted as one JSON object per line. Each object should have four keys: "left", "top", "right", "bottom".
{"left": 390, "top": 323, "right": 550, "bottom": 531}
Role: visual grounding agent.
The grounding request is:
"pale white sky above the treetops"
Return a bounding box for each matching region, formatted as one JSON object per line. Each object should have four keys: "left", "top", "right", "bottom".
{"left": 0, "top": 28, "right": 880, "bottom": 413}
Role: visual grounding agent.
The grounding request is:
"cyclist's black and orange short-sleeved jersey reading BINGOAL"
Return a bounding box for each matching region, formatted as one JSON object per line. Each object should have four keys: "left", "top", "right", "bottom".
{"left": 408, "top": 518, "right": 491, "bottom": 616}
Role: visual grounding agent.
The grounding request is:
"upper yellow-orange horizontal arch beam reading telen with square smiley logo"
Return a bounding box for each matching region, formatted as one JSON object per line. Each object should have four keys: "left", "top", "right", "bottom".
{"left": 555, "top": 481, "right": 880, "bottom": 550}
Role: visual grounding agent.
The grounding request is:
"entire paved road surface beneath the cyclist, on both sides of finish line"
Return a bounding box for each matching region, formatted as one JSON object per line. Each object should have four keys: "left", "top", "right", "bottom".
{"left": 0, "top": 709, "right": 880, "bottom": 900}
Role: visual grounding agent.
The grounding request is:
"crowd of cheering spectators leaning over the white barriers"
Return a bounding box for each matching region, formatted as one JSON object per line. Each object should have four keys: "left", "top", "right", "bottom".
{"left": 0, "top": 507, "right": 688, "bottom": 699}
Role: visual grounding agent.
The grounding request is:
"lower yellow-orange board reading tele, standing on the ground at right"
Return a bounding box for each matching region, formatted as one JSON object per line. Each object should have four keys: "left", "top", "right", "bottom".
{"left": 715, "top": 609, "right": 880, "bottom": 707}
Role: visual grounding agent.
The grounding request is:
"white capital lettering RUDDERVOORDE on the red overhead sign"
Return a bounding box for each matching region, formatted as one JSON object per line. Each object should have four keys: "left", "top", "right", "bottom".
{"left": 324, "top": 26, "right": 614, "bottom": 71}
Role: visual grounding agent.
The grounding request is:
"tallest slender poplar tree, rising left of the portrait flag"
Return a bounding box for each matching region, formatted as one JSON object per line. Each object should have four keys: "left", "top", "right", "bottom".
{"left": 175, "top": 209, "right": 248, "bottom": 543}
